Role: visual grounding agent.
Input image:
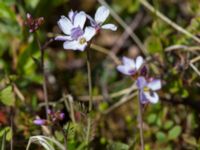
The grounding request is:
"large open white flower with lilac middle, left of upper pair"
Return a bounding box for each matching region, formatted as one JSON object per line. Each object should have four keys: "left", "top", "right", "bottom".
{"left": 55, "top": 11, "right": 95, "bottom": 51}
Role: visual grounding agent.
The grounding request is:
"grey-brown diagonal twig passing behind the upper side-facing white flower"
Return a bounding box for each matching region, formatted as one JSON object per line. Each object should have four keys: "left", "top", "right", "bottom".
{"left": 98, "top": 0, "right": 147, "bottom": 55}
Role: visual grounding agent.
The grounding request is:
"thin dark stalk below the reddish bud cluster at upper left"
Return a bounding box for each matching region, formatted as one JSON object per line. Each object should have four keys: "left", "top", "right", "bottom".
{"left": 35, "top": 33, "right": 49, "bottom": 119}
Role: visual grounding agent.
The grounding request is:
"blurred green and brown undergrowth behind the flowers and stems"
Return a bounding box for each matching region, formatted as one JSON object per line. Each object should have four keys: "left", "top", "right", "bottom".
{"left": 0, "top": 0, "right": 200, "bottom": 150}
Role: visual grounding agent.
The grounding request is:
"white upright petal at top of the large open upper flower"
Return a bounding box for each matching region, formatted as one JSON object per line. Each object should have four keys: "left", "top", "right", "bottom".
{"left": 74, "top": 11, "right": 86, "bottom": 29}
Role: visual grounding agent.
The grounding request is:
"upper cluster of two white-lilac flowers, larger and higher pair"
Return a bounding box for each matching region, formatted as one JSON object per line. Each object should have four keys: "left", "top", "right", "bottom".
{"left": 55, "top": 6, "right": 117, "bottom": 51}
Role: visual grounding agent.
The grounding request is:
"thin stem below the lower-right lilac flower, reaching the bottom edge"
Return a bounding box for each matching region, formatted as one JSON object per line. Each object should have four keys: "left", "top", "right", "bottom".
{"left": 138, "top": 94, "right": 144, "bottom": 150}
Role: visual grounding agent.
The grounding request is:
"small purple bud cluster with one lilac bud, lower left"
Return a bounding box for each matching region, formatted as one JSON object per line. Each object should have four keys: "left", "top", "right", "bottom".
{"left": 33, "top": 110, "right": 65, "bottom": 126}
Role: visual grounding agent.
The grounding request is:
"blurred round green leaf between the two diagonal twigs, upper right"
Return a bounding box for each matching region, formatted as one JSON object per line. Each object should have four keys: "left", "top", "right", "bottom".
{"left": 145, "top": 36, "right": 163, "bottom": 54}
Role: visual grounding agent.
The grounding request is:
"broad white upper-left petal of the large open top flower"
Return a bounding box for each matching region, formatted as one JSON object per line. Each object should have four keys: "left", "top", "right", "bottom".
{"left": 58, "top": 16, "right": 73, "bottom": 35}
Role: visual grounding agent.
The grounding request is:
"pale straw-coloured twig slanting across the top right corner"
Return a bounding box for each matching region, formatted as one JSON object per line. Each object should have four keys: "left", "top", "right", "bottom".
{"left": 140, "top": 0, "right": 200, "bottom": 43}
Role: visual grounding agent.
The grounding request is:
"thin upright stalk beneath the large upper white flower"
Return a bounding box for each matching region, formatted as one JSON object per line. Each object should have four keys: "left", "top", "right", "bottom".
{"left": 86, "top": 49, "right": 92, "bottom": 144}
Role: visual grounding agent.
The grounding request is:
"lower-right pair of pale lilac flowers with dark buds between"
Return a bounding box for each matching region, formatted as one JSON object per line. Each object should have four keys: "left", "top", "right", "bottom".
{"left": 117, "top": 56, "right": 161, "bottom": 104}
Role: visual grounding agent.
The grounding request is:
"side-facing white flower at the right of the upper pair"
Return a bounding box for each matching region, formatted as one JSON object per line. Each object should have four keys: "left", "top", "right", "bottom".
{"left": 87, "top": 6, "right": 117, "bottom": 31}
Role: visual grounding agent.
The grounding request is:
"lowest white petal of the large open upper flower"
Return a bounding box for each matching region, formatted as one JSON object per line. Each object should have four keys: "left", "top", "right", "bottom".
{"left": 63, "top": 41, "right": 87, "bottom": 51}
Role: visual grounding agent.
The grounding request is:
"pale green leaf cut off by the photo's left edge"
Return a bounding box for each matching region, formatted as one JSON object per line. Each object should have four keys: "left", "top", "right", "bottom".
{"left": 0, "top": 85, "right": 15, "bottom": 106}
